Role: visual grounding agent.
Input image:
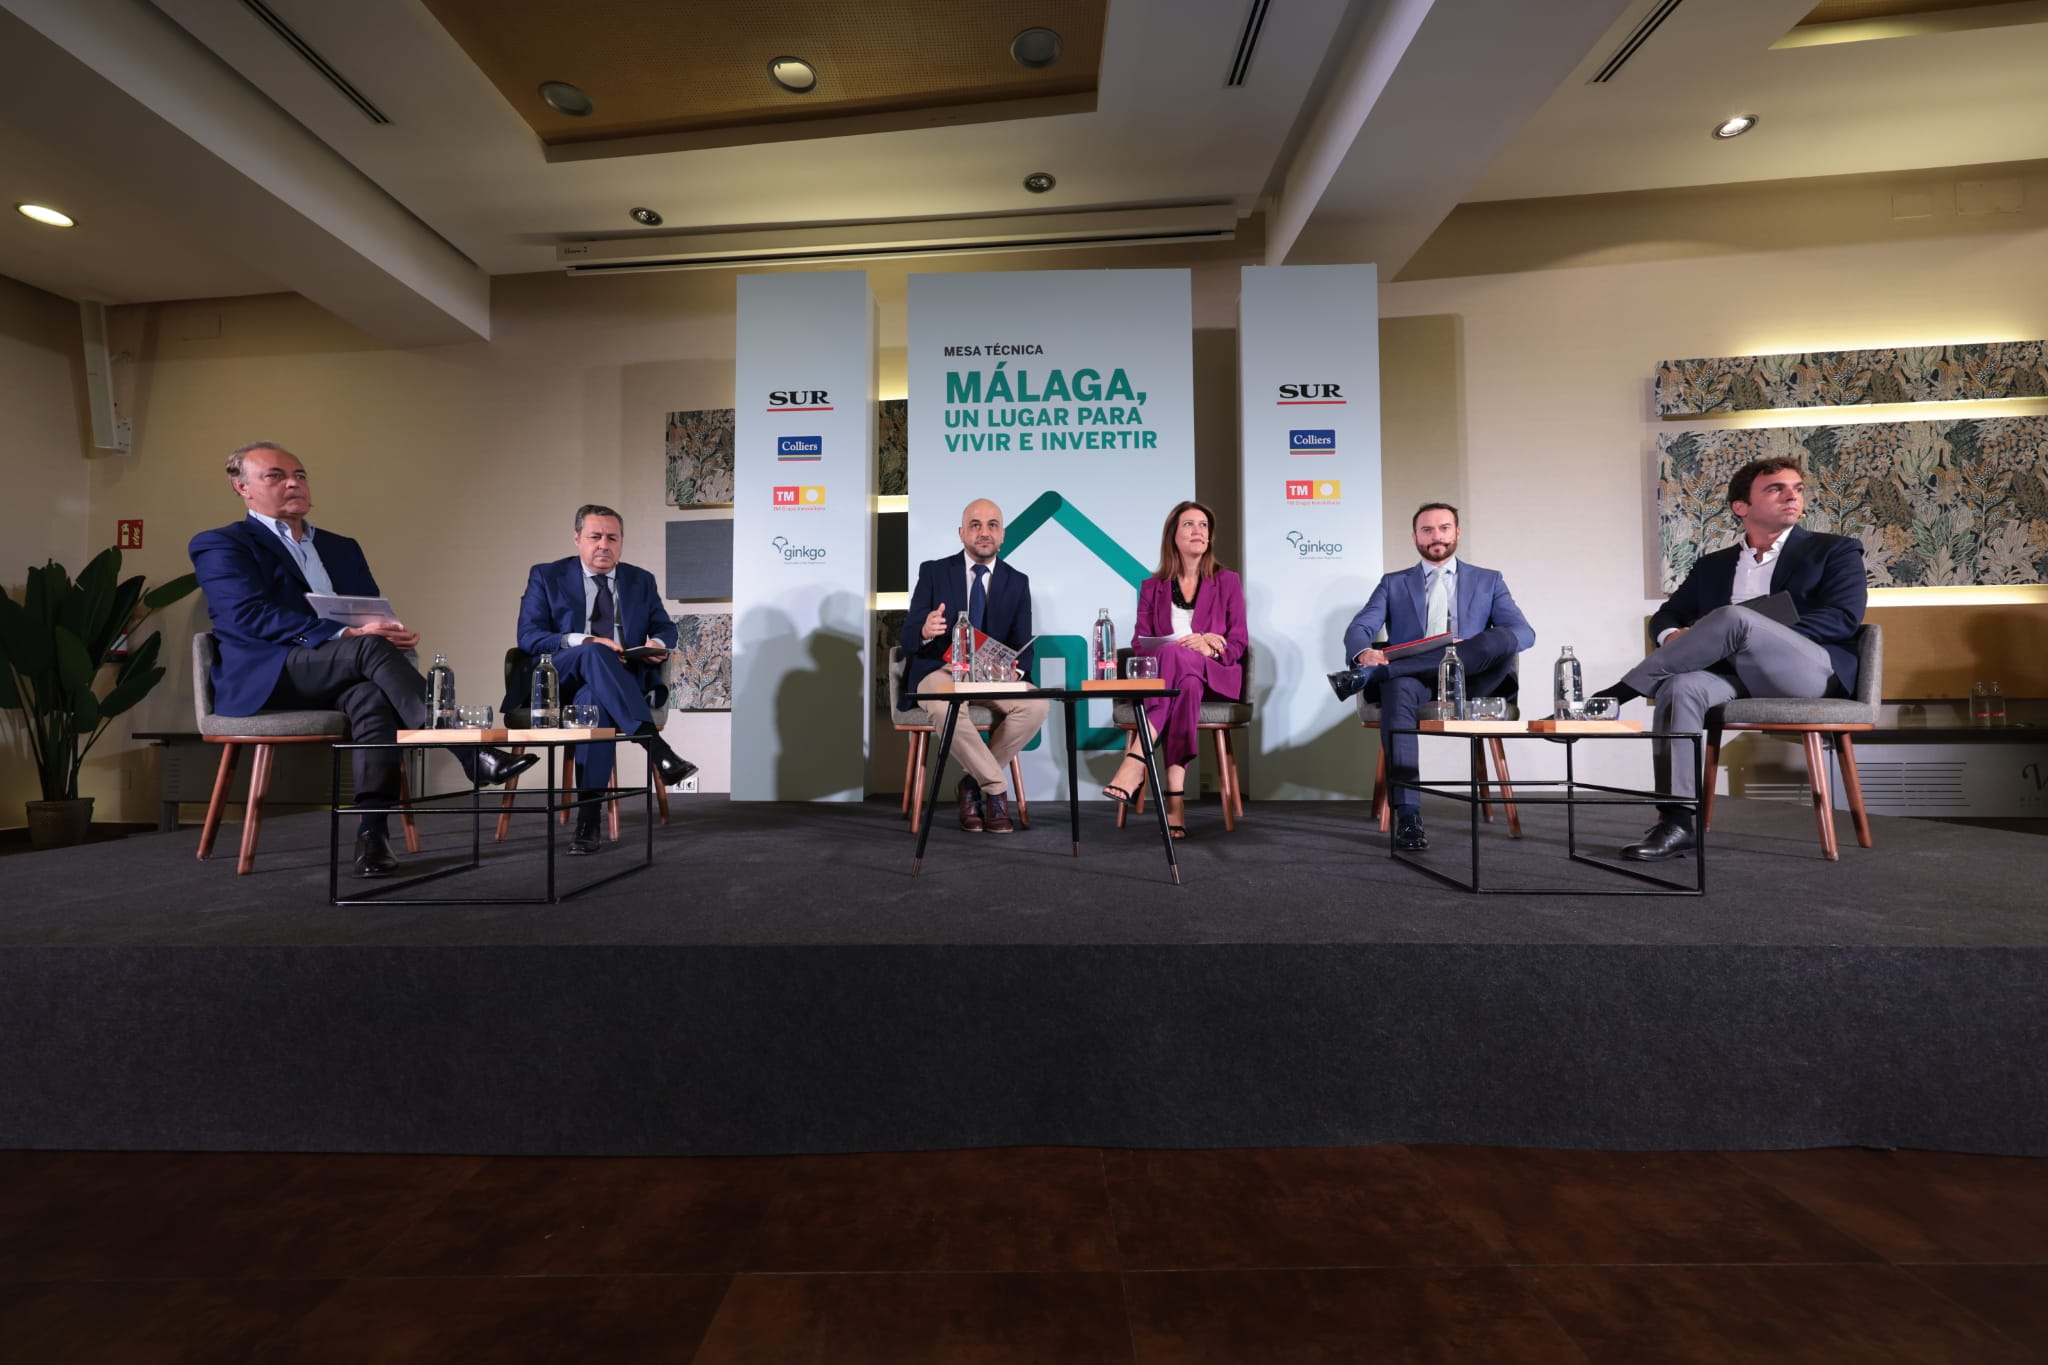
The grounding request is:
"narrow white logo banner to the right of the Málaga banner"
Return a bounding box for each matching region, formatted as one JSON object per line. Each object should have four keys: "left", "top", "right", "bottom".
{"left": 1237, "top": 266, "right": 1382, "bottom": 800}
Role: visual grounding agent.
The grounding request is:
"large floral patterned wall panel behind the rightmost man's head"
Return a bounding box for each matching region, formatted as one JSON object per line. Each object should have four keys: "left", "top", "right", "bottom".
{"left": 1657, "top": 417, "right": 2048, "bottom": 591}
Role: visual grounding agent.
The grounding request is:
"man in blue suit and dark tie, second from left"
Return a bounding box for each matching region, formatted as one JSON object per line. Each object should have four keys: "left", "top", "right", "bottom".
{"left": 506, "top": 503, "right": 696, "bottom": 853}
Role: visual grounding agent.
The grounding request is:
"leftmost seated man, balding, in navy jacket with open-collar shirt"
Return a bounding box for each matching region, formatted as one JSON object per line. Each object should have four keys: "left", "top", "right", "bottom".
{"left": 190, "top": 442, "right": 539, "bottom": 876}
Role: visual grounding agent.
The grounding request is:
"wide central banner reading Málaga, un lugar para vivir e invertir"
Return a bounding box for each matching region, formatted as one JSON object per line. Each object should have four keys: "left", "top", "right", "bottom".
{"left": 909, "top": 270, "right": 1194, "bottom": 796}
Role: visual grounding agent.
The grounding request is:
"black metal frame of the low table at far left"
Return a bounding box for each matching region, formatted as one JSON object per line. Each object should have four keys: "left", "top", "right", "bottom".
{"left": 328, "top": 739, "right": 653, "bottom": 905}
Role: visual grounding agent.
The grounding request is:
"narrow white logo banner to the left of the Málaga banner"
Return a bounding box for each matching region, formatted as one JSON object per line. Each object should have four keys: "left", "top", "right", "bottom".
{"left": 733, "top": 272, "right": 877, "bottom": 800}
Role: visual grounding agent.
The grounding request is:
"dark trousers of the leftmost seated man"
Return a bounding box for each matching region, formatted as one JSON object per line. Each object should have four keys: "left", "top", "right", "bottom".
{"left": 264, "top": 634, "right": 428, "bottom": 829}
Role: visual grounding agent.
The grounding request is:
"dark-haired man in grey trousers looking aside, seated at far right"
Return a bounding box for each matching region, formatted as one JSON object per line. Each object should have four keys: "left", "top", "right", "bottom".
{"left": 1595, "top": 458, "right": 1870, "bottom": 862}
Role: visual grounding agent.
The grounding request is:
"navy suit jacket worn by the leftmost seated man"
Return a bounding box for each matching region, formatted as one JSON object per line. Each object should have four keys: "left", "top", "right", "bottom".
{"left": 186, "top": 518, "right": 383, "bottom": 716}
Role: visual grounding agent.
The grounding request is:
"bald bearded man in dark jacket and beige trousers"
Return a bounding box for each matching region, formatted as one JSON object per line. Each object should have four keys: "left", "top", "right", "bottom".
{"left": 903, "top": 497, "right": 1047, "bottom": 835}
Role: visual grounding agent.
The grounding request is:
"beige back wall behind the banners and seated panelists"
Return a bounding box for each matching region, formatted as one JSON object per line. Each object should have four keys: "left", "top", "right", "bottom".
{"left": 32, "top": 202, "right": 2048, "bottom": 819}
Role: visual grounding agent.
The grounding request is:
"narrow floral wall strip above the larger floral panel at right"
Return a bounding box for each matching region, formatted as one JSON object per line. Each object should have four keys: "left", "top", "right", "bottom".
{"left": 1657, "top": 342, "right": 2048, "bottom": 417}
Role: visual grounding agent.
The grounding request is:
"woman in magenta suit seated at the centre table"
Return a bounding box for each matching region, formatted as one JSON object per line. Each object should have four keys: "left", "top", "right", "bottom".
{"left": 1102, "top": 501, "right": 1245, "bottom": 839}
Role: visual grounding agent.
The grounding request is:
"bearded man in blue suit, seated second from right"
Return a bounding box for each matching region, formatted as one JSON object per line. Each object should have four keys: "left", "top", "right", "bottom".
{"left": 1329, "top": 501, "right": 1536, "bottom": 853}
